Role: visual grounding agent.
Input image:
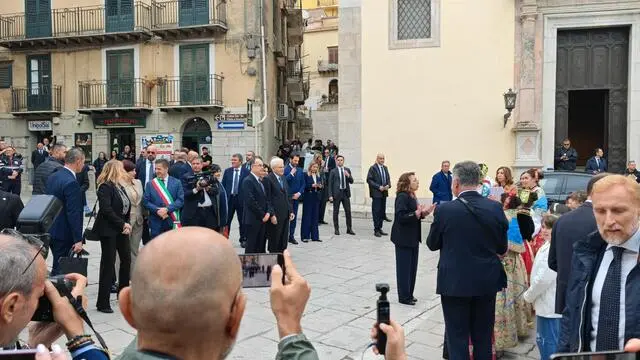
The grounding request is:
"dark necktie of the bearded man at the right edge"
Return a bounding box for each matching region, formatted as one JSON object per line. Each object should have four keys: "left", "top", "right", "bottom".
{"left": 596, "top": 246, "right": 624, "bottom": 351}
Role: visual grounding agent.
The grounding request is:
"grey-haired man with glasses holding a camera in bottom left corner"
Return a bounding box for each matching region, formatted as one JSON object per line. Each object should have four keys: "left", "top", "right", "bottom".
{"left": 0, "top": 234, "right": 108, "bottom": 360}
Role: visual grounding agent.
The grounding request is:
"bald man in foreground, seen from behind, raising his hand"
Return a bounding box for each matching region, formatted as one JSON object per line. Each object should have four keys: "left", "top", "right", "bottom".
{"left": 119, "top": 227, "right": 318, "bottom": 360}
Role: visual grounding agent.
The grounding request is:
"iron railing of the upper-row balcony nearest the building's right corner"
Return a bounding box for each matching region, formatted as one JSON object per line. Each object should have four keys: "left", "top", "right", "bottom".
{"left": 151, "top": 0, "right": 227, "bottom": 29}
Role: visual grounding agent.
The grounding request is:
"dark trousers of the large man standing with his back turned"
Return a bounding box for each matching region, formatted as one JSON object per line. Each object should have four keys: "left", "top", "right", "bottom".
{"left": 441, "top": 294, "right": 496, "bottom": 360}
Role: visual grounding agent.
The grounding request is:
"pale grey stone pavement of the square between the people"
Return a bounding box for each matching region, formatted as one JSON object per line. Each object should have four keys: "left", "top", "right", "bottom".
{"left": 20, "top": 193, "right": 539, "bottom": 360}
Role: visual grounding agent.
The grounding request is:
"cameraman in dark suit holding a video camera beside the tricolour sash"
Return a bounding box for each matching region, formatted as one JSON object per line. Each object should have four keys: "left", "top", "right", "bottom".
{"left": 182, "top": 157, "right": 225, "bottom": 231}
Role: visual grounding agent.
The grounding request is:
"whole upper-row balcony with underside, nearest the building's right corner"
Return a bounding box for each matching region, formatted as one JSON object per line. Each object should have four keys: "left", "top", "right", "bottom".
{"left": 151, "top": 0, "right": 228, "bottom": 40}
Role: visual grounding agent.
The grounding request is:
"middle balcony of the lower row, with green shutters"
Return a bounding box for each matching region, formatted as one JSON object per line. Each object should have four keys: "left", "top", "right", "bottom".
{"left": 78, "top": 79, "right": 152, "bottom": 114}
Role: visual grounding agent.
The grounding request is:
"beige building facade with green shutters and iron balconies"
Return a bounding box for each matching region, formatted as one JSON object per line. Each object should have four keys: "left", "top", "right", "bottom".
{"left": 0, "top": 0, "right": 306, "bottom": 174}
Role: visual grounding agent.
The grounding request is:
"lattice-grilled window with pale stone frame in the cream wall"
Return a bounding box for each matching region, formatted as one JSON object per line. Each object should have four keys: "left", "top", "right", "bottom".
{"left": 389, "top": 0, "right": 440, "bottom": 49}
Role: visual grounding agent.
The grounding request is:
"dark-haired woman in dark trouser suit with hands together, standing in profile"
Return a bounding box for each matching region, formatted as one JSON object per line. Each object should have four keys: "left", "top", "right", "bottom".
{"left": 391, "top": 172, "right": 435, "bottom": 305}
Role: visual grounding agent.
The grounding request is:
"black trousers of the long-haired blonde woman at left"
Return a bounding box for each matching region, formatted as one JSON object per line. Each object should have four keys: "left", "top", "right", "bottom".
{"left": 96, "top": 234, "right": 131, "bottom": 309}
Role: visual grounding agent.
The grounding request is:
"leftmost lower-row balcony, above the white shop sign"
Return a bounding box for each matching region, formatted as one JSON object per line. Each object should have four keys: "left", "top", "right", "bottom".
{"left": 11, "top": 85, "right": 62, "bottom": 118}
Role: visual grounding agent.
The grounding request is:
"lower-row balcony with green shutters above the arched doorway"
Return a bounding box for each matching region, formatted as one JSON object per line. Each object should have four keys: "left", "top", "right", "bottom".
{"left": 158, "top": 74, "right": 224, "bottom": 112}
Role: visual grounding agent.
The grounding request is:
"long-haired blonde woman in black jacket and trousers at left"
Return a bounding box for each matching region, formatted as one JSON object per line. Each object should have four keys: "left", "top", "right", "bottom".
{"left": 93, "top": 160, "right": 131, "bottom": 313}
